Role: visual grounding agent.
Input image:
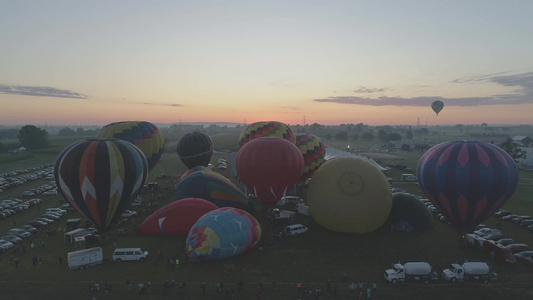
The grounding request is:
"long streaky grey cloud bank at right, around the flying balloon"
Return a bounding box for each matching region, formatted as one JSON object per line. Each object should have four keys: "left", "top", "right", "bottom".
{"left": 313, "top": 72, "right": 533, "bottom": 106}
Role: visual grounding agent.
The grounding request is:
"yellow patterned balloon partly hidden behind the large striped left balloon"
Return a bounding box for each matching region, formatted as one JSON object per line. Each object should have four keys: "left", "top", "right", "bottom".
{"left": 97, "top": 121, "right": 165, "bottom": 171}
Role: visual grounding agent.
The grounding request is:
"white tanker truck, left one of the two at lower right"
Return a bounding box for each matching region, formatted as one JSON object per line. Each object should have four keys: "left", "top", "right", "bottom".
{"left": 384, "top": 262, "right": 438, "bottom": 284}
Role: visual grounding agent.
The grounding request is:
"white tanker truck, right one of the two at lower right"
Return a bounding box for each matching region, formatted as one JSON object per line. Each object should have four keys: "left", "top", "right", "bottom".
{"left": 442, "top": 262, "right": 498, "bottom": 283}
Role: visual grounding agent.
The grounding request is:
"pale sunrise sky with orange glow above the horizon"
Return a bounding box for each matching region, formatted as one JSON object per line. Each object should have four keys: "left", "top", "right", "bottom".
{"left": 0, "top": 0, "right": 533, "bottom": 125}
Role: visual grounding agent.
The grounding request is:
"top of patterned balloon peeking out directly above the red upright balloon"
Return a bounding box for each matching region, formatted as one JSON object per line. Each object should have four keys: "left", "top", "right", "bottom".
{"left": 239, "top": 121, "right": 294, "bottom": 147}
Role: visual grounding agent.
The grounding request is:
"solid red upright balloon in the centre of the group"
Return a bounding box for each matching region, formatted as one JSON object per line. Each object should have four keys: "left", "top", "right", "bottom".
{"left": 235, "top": 137, "right": 304, "bottom": 207}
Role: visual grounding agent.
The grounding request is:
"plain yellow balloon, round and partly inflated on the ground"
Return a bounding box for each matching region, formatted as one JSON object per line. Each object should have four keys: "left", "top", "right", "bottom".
{"left": 307, "top": 157, "right": 392, "bottom": 233}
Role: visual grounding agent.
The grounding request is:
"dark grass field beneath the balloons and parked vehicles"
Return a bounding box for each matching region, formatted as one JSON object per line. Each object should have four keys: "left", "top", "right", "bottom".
{"left": 0, "top": 133, "right": 533, "bottom": 299}
